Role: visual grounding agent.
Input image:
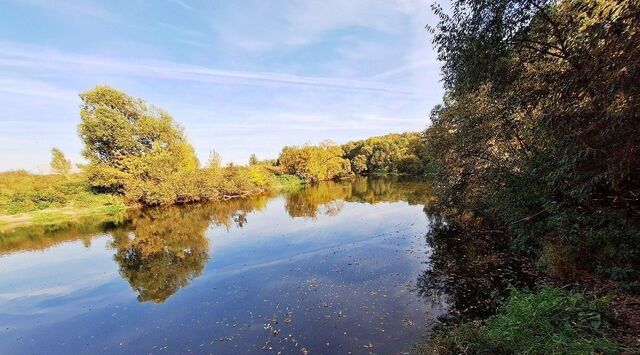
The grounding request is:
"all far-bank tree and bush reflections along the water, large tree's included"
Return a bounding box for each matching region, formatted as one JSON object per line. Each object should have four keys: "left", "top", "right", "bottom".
{"left": 0, "top": 177, "right": 431, "bottom": 303}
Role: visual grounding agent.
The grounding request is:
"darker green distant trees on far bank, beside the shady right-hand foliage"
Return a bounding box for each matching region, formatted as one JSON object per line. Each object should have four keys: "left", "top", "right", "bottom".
{"left": 342, "top": 133, "right": 424, "bottom": 176}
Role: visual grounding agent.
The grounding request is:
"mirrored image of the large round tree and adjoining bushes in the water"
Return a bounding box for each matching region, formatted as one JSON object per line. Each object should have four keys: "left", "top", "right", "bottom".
{"left": 113, "top": 197, "right": 267, "bottom": 303}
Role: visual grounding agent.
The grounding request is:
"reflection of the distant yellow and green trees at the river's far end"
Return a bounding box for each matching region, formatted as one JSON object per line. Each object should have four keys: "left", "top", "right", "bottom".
{"left": 285, "top": 177, "right": 433, "bottom": 218}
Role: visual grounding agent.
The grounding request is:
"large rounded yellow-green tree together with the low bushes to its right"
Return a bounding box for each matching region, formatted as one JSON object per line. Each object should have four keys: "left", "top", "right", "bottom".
{"left": 79, "top": 86, "right": 284, "bottom": 206}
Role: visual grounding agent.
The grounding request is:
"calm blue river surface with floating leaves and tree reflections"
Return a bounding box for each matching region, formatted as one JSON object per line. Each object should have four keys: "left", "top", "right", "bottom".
{"left": 0, "top": 178, "right": 528, "bottom": 354}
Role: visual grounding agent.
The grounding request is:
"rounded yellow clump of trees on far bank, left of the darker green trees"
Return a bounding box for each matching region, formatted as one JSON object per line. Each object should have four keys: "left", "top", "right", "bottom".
{"left": 278, "top": 142, "right": 352, "bottom": 182}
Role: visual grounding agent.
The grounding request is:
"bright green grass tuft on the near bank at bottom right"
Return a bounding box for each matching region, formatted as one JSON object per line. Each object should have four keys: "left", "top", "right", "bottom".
{"left": 415, "top": 287, "right": 618, "bottom": 354}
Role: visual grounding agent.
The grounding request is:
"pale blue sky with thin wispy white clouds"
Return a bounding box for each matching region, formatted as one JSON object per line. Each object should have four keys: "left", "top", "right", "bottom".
{"left": 0, "top": 0, "right": 443, "bottom": 172}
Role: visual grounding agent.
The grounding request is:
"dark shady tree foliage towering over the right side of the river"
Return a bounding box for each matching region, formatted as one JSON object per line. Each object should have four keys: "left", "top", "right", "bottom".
{"left": 424, "top": 0, "right": 640, "bottom": 288}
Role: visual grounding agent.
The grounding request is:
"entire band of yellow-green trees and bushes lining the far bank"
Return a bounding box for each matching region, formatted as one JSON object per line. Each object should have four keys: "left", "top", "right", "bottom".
{"left": 0, "top": 86, "right": 425, "bottom": 215}
